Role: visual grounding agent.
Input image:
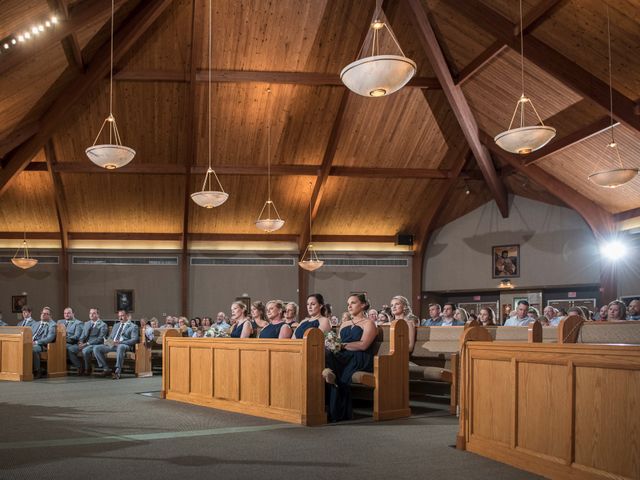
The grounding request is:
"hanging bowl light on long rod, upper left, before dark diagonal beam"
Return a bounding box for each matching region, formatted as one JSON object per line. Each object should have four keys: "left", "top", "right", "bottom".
{"left": 85, "top": 0, "right": 136, "bottom": 170}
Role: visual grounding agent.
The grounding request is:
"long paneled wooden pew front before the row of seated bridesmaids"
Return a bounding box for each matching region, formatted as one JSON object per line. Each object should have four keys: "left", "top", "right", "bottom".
{"left": 161, "top": 328, "right": 327, "bottom": 425}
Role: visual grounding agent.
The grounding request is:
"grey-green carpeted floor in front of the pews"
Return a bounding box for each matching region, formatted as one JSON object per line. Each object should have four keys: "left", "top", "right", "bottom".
{"left": 0, "top": 377, "right": 537, "bottom": 480}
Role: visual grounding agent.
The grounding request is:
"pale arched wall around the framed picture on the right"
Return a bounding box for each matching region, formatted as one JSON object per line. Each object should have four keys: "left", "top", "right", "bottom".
{"left": 424, "top": 196, "right": 600, "bottom": 291}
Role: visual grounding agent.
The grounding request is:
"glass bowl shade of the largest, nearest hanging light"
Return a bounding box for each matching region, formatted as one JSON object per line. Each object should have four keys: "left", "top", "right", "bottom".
{"left": 340, "top": 55, "right": 416, "bottom": 97}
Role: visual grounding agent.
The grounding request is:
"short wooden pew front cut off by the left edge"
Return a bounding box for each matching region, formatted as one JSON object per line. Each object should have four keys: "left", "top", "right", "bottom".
{"left": 0, "top": 327, "right": 33, "bottom": 382}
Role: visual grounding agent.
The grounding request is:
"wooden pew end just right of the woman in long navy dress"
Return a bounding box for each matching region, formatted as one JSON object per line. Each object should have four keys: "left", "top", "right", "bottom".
{"left": 351, "top": 320, "right": 411, "bottom": 421}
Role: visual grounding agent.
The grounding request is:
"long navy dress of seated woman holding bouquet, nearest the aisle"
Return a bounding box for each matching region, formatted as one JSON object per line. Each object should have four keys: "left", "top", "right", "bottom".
{"left": 324, "top": 325, "right": 373, "bottom": 422}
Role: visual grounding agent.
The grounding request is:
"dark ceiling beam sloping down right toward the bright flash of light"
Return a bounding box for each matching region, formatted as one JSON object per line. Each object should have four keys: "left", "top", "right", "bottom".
{"left": 480, "top": 132, "right": 615, "bottom": 238}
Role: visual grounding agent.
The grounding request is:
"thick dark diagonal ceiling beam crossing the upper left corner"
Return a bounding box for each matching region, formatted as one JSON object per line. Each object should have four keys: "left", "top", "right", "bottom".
{"left": 0, "top": 0, "right": 172, "bottom": 195}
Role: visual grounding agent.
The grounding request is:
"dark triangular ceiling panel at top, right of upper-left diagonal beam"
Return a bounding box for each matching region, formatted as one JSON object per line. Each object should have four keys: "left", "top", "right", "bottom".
{"left": 119, "top": 0, "right": 190, "bottom": 71}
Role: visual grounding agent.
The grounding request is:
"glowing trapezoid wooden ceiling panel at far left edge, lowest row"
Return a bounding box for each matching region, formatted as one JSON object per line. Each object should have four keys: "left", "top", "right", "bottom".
{"left": 0, "top": 166, "right": 59, "bottom": 233}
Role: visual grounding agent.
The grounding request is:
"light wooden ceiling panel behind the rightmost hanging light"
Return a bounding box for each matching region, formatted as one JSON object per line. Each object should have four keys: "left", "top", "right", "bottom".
{"left": 537, "top": 125, "right": 640, "bottom": 213}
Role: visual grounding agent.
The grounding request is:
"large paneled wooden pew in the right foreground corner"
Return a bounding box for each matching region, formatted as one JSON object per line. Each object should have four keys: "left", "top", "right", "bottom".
{"left": 457, "top": 319, "right": 640, "bottom": 479}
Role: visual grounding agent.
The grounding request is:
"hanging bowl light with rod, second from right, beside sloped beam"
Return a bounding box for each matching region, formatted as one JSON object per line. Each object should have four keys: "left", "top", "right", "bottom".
{"left": 493, "top": 0, "right": 556, "bottom": 155}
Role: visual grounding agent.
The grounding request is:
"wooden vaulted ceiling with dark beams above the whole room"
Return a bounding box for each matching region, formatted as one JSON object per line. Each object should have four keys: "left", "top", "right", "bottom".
{"left": 0, "top": 0, "right": 640, "bottom": 244}
